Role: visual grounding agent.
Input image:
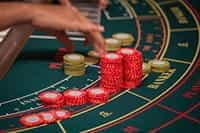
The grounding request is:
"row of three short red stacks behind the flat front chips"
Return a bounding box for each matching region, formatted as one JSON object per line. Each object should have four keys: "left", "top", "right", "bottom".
{"left": 38, "top": 87, "right": 109, "bottom": 109}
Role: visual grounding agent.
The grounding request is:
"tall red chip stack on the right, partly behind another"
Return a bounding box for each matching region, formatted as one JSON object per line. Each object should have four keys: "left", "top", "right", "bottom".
{"left": 118, "top": 48, "right": 143, "bottom": 89}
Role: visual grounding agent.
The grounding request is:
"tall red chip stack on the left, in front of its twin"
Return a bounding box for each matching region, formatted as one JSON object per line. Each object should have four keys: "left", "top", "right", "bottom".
{"left": 100, "top": 53, "right": 123, "bottom": 93}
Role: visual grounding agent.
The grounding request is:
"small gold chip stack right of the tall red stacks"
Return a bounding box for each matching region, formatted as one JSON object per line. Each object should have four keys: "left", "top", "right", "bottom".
{"left": 148, "top": 59, "right": 170, "bottom": 73}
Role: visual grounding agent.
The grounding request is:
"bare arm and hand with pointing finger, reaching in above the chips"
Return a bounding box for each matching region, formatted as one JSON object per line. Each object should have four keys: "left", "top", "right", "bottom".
{"left": 0, "top": 2, "right": 104, "bottom": 32}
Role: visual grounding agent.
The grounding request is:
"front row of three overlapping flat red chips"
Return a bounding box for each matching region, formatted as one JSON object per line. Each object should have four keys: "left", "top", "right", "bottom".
{"left": 19, "top": 109, "right": 71, "bottom": 127}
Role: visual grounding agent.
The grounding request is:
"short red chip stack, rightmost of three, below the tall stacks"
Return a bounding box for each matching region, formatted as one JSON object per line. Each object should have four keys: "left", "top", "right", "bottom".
{"left": 86, "top": 88, "right": 109, "bottom": 104}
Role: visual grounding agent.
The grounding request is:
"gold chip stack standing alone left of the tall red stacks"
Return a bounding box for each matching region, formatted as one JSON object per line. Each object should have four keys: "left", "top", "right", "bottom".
{"left": 63, "top": 53, "right": 86, "bottom": 76}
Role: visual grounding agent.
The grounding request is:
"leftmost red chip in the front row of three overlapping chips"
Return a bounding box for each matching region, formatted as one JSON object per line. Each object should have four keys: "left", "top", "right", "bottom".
{"left": 19, "top": 114, "right": 44, "bottom": 127}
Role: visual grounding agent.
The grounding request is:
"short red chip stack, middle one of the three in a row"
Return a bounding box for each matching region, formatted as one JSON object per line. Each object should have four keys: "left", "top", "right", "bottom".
{"left": 64, "top": 90, "right": 87, "bottom": 106}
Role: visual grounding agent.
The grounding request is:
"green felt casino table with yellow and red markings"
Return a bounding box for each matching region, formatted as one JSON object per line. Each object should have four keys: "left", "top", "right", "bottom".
{"left": 0, "top": 0, "right": 200, "bottom": 133}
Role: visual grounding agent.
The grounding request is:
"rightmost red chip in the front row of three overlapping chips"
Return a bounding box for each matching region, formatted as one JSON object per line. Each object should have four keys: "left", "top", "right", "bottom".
{"left": 51, "top": 109, "right": 72, "bottom": 120}
